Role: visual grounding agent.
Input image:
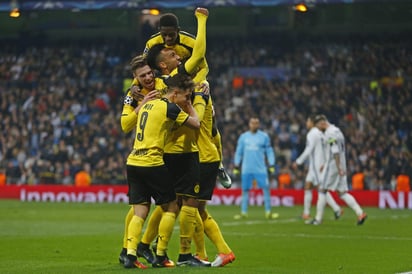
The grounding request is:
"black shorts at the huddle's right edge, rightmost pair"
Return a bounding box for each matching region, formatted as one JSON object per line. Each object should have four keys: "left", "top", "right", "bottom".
{"left": 198, "top": 162, "right": 220, "bottom": 201}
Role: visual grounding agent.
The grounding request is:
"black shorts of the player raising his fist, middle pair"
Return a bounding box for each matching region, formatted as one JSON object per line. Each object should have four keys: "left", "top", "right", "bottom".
{"left": 163, "top": 152, "right": 200, "bottom": 198}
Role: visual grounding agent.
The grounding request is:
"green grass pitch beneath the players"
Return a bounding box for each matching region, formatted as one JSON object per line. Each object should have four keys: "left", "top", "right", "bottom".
{"left": 0, "top": 200, "right": 412, "bottom": 274}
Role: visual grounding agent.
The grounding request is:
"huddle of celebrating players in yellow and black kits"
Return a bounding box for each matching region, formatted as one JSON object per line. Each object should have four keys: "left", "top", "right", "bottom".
{"left": 119, "top": 8, "right": 235, "bottom": 268}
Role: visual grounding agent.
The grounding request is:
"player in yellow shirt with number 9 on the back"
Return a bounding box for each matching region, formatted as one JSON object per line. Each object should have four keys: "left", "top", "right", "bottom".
{"left": 124, "top": 75, "right": 200, "bottom": 268}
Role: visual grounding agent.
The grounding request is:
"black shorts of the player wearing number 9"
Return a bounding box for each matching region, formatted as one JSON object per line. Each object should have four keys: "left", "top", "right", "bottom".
{"left": 127, "top": 165, "right": 176, "bottom": 205}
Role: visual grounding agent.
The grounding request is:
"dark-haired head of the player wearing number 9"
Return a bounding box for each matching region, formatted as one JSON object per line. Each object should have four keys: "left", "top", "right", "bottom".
{"left": 165, "top": 73, "right": 195, "bottom": 104}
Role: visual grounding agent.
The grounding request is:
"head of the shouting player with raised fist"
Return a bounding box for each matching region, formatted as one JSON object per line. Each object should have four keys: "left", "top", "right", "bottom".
{"left": 147, "top": 44, "right": 181, "bottom": 74}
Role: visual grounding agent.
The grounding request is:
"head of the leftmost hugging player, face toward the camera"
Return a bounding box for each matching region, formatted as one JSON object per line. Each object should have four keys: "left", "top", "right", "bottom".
{"left": 130, "top": 55, "right": 155, "bottom": 91}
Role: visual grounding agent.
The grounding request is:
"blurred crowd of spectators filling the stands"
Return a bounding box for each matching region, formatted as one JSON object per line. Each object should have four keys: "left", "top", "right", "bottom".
{"left": 0, "top": 33, "right": 412, "bottom": 189}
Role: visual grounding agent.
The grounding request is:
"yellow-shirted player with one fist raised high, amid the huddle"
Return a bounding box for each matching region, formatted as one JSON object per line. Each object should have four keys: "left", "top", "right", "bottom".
{"left": 138, "top": 6, "right": 210, "bottom": 266}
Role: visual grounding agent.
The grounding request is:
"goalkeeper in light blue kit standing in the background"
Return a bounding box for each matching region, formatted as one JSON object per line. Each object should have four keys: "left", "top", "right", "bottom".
{"left": 233, "top": 117, "right": 279, "bottom": 219}
